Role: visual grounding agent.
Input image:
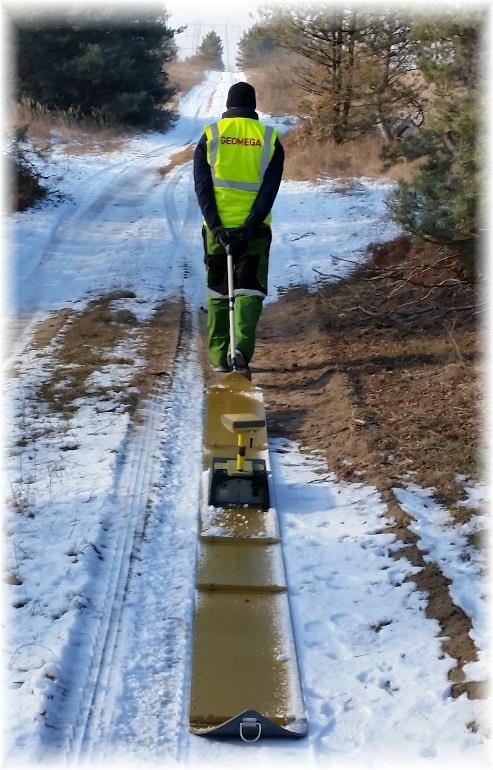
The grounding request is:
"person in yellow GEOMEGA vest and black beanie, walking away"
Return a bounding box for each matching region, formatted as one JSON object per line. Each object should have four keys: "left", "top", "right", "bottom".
{"left": 194, "top": 82, "right": 284, "bottom": 379}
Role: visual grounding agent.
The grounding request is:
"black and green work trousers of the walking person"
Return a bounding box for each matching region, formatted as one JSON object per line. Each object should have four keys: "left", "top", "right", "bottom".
{"left": 203, "top": 220, "right": 272, "bottom": 366}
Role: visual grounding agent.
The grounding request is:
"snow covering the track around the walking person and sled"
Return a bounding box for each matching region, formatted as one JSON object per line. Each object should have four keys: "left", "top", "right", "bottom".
{"left": 6, "top": 72, "right": 486, "bottom": 767}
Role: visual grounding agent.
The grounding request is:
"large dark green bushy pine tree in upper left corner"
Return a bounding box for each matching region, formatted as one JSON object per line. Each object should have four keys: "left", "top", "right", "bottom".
{"left": 14, "top": 9, "right": 176, "bottom": 126}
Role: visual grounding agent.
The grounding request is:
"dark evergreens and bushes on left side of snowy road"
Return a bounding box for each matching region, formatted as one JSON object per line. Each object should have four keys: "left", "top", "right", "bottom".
{"left": 9, "top": 8, "right": 224, "bottom": 209}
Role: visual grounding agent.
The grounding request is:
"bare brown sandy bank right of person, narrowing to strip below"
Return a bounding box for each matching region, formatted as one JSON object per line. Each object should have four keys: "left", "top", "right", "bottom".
{"left": 252, "top": 244, "right": 484, "bottom": 697}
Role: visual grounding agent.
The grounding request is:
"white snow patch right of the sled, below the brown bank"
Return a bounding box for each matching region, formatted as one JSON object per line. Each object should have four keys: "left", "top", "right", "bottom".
{"left": 188, "top": 439, "right": 488, "bottom": 768}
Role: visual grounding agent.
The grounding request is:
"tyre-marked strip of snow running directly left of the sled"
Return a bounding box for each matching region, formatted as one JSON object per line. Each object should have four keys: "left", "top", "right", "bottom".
{"left": 86, "top": 312, "right": 203, "bottom": 761}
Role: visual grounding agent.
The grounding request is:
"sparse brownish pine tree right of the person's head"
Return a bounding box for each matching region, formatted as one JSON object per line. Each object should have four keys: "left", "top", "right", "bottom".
{"left": 258, "top": 5, "right": 419, "bottom": 144}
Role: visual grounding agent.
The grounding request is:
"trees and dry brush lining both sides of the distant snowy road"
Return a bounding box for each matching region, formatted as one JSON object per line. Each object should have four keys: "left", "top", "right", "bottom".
{"left": 6, "top": 5, "right": 486, "bottom": 272}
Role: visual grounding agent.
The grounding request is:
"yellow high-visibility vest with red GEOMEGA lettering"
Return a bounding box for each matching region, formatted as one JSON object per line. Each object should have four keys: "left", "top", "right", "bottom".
{"left": 204, "top": 118, "right": 278, "bottom": 227}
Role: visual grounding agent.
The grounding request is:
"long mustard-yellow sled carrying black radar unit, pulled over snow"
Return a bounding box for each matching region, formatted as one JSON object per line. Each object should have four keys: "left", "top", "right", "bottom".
{"left": 189, "top": 246, "right": 307, "bottom": 742}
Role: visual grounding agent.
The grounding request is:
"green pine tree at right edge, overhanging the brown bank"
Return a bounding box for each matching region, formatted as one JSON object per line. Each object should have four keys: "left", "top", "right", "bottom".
{"left": 387, "top": 13, "right": 481, "bottom": 258}
